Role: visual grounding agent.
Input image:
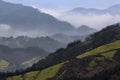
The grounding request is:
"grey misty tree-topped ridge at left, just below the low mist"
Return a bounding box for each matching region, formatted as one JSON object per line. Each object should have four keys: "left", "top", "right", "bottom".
{"left": 0, "top": 36, "right": 66, "bottom": 52}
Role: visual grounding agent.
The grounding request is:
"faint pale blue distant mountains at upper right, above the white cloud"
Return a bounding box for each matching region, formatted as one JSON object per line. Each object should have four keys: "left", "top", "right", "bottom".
{"left": 69, "top": 4, "right": 120, "bottom": 15}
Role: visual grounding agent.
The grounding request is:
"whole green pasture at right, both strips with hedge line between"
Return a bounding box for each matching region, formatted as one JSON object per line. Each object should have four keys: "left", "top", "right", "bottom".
{"left": 77, "top": 40, "right": 120, "bottom": 59}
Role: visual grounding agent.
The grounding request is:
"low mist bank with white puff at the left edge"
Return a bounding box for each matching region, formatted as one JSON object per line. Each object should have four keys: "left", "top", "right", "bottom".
{"left": 0, "top": 24, "right": 46, "bottom": 37}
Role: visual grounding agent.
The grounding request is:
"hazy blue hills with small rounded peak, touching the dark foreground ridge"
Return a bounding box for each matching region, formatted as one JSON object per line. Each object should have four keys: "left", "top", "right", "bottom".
{"left": 51, "top": 25, "right": 97, "bottom": 43}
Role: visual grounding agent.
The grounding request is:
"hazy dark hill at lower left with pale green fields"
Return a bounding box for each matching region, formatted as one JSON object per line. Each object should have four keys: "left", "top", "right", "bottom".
{"left": 0, "top": 45, "right": 48, "bottom": 71}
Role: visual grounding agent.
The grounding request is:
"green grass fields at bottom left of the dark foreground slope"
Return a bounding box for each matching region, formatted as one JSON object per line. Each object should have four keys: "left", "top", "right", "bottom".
{"left": 7, "top": 63, "right": 64, "bottom": 80}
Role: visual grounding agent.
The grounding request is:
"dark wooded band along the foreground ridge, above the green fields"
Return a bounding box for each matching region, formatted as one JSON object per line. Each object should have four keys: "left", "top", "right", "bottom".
{"left": 22, "top": 24, "right": 120, "bottom": 71}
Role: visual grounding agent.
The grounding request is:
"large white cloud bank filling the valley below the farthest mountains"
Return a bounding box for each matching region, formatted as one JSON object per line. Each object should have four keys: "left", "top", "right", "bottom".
{"left": 41, "top": 9, "right": 120, "bottom": 30}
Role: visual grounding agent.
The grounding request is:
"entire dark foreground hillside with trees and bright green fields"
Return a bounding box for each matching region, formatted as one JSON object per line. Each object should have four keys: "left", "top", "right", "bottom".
{"left": 0, "top": 24, "right": 120, "bottom": 80}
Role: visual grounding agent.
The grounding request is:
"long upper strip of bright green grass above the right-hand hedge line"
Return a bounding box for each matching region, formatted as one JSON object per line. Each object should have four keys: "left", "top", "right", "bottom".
{"left": 77, "top": 40, "right": 120, "bottom": 59}
